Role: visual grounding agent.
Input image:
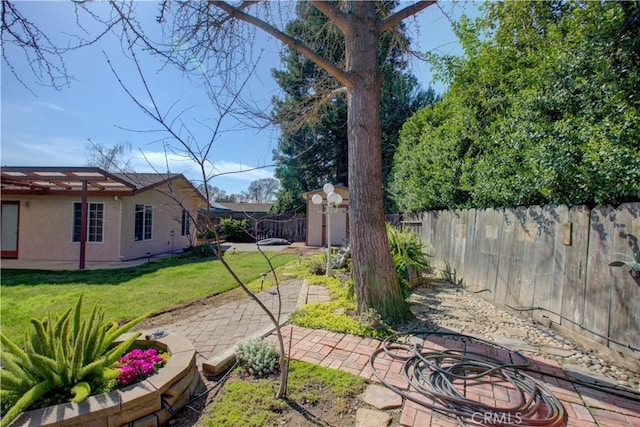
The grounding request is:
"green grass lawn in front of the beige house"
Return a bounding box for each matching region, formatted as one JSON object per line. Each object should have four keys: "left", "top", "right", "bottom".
{"left": 0, "top": 252, "right": 298, "bottom": 343}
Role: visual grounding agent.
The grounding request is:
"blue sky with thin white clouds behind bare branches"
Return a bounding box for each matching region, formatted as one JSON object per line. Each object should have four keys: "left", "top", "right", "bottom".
{"left": 0, "top": 1, "right": 477, "bottom": 193}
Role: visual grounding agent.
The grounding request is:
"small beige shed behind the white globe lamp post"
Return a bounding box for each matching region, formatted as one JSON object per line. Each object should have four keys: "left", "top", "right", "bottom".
{"left": 303, "top": 185, "right": 349, "bottom": 246}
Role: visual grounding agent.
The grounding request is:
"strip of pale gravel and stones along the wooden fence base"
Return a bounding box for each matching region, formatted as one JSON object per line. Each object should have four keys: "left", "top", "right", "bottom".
{"left": 399, "top": 281, "right": 640, "bottom": 392}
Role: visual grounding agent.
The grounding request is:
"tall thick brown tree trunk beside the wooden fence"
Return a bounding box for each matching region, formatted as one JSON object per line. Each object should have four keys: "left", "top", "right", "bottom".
{"left": 345, "top": 1, "right": 408, "bottom": 323}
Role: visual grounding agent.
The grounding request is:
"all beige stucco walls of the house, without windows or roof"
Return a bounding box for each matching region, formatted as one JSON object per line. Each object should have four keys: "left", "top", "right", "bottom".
{"left": 2, "top": 179, "right": 206, "bottom": 262}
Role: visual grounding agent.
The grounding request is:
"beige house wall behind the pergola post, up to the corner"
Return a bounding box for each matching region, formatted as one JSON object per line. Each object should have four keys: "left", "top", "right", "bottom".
{"left": 3, "top": 195, "right": 120, "bottom": 261}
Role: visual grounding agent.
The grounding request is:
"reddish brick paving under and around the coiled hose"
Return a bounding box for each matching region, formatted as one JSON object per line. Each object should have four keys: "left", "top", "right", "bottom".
{"left": 272, "top": 326, "right": 640, "bottom": 427}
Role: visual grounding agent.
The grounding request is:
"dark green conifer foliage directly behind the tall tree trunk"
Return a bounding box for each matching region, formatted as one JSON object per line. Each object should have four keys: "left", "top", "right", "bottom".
{"left": 272, "top": 2, "right": 435, "bottom": 212}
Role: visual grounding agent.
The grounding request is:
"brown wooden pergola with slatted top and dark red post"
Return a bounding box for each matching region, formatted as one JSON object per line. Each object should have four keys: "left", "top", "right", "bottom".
{"left": 0, "top": 166, "right": 136, "bottom": 270}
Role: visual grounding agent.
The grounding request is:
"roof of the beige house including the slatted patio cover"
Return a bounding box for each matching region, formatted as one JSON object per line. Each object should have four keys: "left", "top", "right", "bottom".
{"left": 0, "top": 166, "right": 204, "bottom": 206}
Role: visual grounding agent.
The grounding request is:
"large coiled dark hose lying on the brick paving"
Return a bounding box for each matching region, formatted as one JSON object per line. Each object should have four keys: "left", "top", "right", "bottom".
{"left": 369, "top": 331, "right": 567, "bottom": 427}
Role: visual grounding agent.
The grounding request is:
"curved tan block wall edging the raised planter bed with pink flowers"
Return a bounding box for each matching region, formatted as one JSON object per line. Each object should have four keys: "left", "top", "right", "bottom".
{"left": 11, "top": 334, "right": 200, "bottom": 427}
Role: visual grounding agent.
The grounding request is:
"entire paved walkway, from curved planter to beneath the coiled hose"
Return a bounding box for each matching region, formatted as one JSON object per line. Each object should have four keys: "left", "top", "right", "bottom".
{"left": 151, "top": 280, "right": 640, "bottom": 427}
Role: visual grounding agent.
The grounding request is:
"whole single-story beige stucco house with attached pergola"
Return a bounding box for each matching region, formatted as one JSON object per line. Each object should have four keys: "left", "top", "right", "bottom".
{"left": 0, "top": 167, "right": 207, "bottom": 269}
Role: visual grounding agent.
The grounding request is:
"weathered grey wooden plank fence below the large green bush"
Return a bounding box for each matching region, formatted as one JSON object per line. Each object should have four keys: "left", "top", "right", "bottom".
{"left": 402, "top": 203, "right": 640, "bottom": 366}
